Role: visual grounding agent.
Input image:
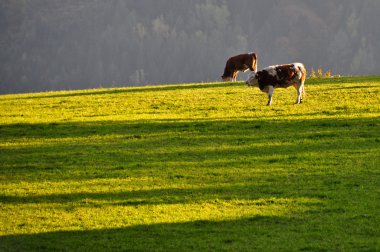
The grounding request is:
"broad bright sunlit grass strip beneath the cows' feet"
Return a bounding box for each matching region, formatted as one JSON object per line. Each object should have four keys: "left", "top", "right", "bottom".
{"left": 0, "top": 77, "right": 379, "bottom": 123}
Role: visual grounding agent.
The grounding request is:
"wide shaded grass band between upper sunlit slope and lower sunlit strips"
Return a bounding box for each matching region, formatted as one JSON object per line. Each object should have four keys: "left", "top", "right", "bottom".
{"left": 0, "top": 118, "right": 380, "bottom": 179}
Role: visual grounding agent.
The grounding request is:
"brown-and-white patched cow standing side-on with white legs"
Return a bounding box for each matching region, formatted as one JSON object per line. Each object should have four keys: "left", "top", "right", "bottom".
{"left": 246, "top": 63, "right": 306, "bottom": 106}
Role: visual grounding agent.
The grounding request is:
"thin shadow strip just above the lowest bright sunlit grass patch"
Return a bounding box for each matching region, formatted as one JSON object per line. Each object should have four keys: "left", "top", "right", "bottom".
{"left": 0, "top": 181, "right": 325, "bottom": 209}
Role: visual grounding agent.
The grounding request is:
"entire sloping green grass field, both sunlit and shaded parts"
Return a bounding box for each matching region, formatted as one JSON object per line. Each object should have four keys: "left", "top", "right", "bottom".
{"left": 0, "top": 76, "right": 380, "bottom": 251}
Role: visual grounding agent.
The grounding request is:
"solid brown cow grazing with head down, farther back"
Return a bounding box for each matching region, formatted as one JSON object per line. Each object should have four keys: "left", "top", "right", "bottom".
{"left": 222, "top": 53, "right": 257, "bottom": 81}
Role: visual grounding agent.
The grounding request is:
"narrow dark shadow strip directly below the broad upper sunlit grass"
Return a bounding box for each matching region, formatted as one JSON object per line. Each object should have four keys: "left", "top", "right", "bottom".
{"left": 0, "top": 113, "right": 380, "bottom": 141}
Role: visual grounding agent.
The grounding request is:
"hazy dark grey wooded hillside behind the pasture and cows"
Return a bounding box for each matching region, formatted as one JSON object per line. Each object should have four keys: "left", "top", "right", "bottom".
{"left": 0, "top": 0, "right": 380, "bottom": 93}
